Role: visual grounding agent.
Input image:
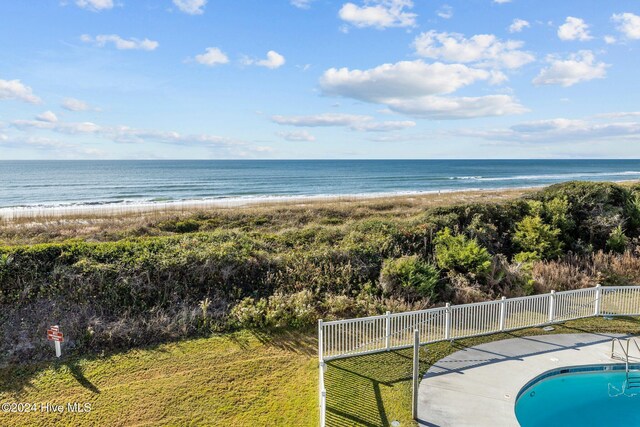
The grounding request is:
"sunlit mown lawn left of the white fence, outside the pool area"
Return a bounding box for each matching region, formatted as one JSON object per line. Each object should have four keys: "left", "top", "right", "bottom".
{"left": 0, "top": 331, "right": 318, "bottom": 427}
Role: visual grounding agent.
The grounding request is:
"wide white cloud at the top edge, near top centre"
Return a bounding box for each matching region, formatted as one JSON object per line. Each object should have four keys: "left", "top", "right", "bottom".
{"left": 338, "top": 0, "right": 417, "bottom": 29}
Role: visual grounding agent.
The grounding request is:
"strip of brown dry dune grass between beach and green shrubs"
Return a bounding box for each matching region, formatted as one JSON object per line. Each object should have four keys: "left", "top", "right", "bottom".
{"left": 0, "top": 189, "right": 534, "bottom": 245}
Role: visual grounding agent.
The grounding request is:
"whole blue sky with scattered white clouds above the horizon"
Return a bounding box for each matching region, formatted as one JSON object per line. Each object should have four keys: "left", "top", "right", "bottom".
{"left": 0, "top": 0, "right": 640, "bottom": 159}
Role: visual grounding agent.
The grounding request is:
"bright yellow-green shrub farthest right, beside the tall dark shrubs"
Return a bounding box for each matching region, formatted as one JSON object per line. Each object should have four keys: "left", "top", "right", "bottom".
{"left": 513, "top": 216, "right": 562, "bottom": 259}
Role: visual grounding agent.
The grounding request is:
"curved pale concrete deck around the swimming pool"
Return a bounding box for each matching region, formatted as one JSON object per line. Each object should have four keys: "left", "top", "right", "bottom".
{"left": 418, "top": 333, "right": 626, "bottom": 427}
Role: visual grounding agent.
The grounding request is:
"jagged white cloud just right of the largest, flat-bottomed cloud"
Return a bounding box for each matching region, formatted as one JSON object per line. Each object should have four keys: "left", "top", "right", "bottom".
{"left": 533, "top": 50, "right": 609, "bottom": 87}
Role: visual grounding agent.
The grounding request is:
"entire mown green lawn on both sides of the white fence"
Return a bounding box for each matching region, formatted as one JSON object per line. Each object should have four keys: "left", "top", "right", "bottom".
{"left": 0, "top": 318, "right": 640, "bottom": 427}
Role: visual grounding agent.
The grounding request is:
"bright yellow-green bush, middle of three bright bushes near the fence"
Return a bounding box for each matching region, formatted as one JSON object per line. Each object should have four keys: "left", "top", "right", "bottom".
{"left": 434, "top": 228, "right": 491, "bottom": 275}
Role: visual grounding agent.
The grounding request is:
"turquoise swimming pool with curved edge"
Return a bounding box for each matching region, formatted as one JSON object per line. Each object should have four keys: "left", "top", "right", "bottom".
{"left": 515, "top": 365, "right": 640, "bottom": 427}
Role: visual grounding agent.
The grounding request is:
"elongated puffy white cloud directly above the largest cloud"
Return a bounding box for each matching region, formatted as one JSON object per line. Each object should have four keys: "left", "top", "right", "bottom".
{"left": 413, "top": 30, "right": 535, "bottom": 69}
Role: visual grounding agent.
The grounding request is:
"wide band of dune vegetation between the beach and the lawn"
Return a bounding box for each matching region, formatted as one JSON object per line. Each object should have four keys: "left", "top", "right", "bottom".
{"left": 0, "top": 182, "right": 640, "bottom": 364}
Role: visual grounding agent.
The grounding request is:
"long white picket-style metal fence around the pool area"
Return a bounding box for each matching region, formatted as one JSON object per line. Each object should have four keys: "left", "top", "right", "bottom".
{"left": 318, "top": 285, "right": 640, "bottom": 427}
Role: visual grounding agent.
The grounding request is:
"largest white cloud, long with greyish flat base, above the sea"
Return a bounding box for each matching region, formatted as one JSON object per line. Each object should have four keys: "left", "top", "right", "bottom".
{"left": 320, "top": 60, "right": 526, "bottom": 119}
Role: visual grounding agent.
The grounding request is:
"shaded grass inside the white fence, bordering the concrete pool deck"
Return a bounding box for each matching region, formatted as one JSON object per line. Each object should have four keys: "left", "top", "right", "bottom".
{"left": 325, "top": 318, "right": 640, "bottom": 427}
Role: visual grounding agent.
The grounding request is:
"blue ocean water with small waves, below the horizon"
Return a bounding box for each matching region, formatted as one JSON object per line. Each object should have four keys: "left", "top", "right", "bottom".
{"left": 0, "top": 160, "right": 640, "bottom": 208}
